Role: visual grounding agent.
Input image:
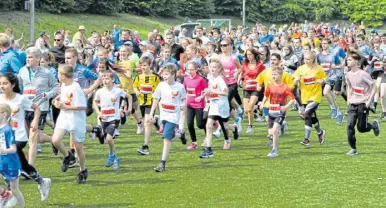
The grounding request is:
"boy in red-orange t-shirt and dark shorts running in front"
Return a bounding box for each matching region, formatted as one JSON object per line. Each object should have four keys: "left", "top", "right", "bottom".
{"left": 260, "top": 67, "right": 295, "bottom": 157}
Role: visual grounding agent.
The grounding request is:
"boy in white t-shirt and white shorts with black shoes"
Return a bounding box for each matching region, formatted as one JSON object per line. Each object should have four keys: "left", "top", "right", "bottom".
{"left": 52, "top": 65, "right": 88, "bottom": 183}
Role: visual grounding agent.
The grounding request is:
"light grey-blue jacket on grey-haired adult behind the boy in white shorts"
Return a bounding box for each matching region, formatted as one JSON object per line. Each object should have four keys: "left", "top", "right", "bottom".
{"left": 19, "top": 66, "right": 58, "bottom": 111}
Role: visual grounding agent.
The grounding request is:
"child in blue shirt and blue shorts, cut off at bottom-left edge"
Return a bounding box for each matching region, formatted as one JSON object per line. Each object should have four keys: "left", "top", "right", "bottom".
{"left": 0, "top": 104, "right": 25, "bottom": 208}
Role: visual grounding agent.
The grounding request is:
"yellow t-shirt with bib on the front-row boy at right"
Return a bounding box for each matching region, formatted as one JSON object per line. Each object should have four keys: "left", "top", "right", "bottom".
{"left": 293, "top": 65, "right": 327, "bottom": 104}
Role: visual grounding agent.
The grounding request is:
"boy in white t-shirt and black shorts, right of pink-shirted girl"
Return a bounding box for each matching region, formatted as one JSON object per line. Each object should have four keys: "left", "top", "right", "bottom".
{"left": 200, "top": 59, "right": 239, "bottom": 158}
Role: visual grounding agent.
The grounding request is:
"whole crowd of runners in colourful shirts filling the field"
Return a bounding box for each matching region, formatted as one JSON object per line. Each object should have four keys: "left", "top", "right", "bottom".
{"left": 0, "top": 22, "right": 386, "bottom": 207}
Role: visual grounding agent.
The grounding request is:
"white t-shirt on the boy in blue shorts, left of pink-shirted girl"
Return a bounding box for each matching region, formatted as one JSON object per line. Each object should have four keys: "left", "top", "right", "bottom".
{"left": 153, "top": 82, "right": 186, "bottom": 124}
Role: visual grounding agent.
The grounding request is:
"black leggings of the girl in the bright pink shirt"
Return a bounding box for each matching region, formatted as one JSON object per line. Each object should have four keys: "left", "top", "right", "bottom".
{"left": 186, "top": 106, "right": 207, "bottom": 142}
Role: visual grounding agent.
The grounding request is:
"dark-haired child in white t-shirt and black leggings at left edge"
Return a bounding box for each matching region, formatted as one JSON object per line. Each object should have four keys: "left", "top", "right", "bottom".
{"left": 0, "top": 73, "right": 51, "bottom": 201}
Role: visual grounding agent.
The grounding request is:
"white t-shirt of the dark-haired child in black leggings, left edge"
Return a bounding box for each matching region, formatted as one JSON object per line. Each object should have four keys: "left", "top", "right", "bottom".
{"left": 0, "top": 94, "right": 33, "bottom": 142}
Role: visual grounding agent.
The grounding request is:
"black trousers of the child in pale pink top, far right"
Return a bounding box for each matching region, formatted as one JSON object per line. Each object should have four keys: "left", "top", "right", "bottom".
{"left": 347, "top": 103, "right": 374, "bottom": 149}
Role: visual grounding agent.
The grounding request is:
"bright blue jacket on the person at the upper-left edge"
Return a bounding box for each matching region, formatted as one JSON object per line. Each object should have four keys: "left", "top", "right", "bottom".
{"left": 0, "top": 48, "right": 23, "bottom": 74}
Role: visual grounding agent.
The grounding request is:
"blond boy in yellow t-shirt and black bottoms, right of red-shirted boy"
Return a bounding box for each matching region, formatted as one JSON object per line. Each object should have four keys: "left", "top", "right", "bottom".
{"left": 293, "top": 51, "right": 327, "bottom": 147}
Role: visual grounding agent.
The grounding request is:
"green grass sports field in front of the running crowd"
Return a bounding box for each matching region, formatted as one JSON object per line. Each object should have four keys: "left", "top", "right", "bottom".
{"left": 20, "top": 98, "right": 386, "bottom": 208}
